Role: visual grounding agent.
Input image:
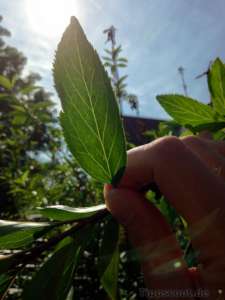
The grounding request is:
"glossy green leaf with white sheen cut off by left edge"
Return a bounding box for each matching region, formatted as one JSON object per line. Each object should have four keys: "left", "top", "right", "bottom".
{"left": 0, "top": 220, "right": 52, "bottom": 249}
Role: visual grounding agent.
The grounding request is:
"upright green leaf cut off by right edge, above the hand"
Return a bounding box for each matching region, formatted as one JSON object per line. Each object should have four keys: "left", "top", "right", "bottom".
{"left": 208, "top": 58, "right": 225, "bottom": 116}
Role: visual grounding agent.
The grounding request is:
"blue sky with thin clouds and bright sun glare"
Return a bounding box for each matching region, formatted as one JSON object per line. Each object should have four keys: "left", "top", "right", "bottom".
{"left": 0, "top": 0, "right": 225, "bottom": 119}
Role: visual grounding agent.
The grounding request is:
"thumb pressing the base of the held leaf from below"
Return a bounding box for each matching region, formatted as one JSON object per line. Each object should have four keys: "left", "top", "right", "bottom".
{"left": 104, "top": 185, "right": 192, "bottom": 292}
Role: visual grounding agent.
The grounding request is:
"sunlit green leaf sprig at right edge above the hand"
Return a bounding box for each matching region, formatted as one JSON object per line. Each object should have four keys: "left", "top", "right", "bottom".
{"left": 157, "top": 58, "right": 225, "bottom": 133}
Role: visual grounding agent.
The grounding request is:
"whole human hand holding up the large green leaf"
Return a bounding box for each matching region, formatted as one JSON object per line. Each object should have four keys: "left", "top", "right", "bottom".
{"left": 104, "top": 137, "right": 225, "bottom": 300}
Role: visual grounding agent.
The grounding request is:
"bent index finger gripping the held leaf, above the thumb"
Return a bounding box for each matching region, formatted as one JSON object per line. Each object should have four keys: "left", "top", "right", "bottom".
{"left": 119, "top": 137, "right": 225, "bottom": 224}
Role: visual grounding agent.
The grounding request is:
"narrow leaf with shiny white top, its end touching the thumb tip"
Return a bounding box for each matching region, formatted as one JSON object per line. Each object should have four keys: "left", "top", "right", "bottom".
{"left": 39, "top": 204, "right": 106, "bottom": 221}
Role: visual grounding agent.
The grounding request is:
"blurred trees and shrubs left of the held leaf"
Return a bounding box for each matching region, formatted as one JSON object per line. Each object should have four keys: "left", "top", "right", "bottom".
{"left": 0, "top": 17, "right": 102, "bottom": 220}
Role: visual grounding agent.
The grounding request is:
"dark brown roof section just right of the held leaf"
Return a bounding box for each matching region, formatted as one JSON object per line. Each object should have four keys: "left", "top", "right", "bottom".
{"left": 123, "top": 116, "right": 163, "bottom": 145}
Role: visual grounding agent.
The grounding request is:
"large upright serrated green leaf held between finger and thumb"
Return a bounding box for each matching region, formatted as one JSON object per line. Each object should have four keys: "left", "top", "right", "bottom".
{"left": 54, "top": 17, "right": 126, "bottom": 184}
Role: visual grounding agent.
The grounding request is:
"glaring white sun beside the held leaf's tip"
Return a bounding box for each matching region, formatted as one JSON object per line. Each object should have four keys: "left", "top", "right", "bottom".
{"left": 25, "top": 0, "right": 81, "bottom": 38}
